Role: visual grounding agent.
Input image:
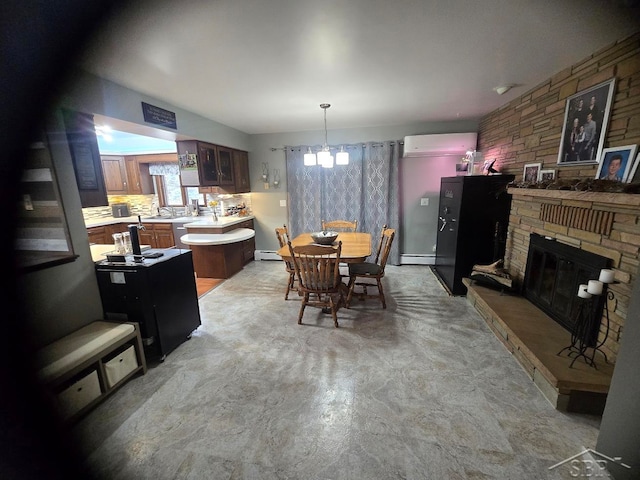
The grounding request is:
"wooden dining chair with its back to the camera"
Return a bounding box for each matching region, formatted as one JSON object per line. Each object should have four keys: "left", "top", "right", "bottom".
{"left": 288, "top": 242, "right": 344, "bottom": 327}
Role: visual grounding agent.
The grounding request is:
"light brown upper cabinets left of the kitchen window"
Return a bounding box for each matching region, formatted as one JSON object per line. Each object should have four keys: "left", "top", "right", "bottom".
{"left": 100, "top": 155, "right": 154, "bottom": 195}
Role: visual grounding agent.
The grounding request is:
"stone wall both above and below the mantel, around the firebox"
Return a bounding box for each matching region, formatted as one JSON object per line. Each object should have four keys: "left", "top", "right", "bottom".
{"left": 478, "top": 31, "right": 640, "bottom": 359}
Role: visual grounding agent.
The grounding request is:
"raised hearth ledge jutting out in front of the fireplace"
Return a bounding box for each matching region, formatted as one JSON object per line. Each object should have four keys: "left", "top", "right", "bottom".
{"left": 463, "top": 278, "right": 614, "bottom": 415}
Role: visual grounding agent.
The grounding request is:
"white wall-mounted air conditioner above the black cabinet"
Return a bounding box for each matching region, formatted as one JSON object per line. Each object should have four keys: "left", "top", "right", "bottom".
{"left": 402, "top": 132, "right": 478, "bottom": 157}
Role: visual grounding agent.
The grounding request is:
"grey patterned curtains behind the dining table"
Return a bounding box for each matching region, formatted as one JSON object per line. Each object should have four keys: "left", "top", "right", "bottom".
{"left": 285, "top": 141, "right": 400, "bottom": 265}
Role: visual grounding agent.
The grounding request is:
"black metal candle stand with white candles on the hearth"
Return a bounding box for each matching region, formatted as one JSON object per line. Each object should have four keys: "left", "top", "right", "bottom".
{"left": 557, "top": 269, "right": 617, "bottom": 370}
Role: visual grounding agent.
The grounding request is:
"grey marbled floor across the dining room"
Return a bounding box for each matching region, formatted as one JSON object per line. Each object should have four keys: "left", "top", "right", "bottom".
{"left": 73, "top": 261, "right": 600, "bottom": 480}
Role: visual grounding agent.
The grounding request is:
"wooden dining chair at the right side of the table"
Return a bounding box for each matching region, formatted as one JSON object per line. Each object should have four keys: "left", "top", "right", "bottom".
{"left": 346, "top": 225, "right": 396, "bottom": 308}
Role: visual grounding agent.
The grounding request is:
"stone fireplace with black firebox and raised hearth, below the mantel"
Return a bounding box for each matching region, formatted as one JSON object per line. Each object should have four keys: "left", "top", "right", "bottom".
{"left": 463, "top": 188, "right": 640, "bottom": 415}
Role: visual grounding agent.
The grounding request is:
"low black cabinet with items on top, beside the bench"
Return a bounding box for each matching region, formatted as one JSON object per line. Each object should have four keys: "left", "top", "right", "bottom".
{"left": 96, "top": 248, "right": 201, "bottom": 361}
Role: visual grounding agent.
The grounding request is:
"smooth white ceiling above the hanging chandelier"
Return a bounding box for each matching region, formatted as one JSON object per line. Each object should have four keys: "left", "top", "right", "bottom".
{"left": 81, "top": 0, "right": 640, "bottom": 134}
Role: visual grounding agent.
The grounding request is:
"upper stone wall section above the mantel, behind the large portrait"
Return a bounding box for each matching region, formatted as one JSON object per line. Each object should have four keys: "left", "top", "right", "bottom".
{"left": 478, "top": 32, "right": 640, "bottom": 181}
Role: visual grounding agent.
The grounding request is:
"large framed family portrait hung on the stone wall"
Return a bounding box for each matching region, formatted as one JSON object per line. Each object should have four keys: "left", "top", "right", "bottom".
{"left": 558, "top": 78, "right": 615, "bottom": 165}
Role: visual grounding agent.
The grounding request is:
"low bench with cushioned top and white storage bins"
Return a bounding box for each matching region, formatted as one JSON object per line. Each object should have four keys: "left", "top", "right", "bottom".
{"left": 36, "top": 321, "right": 147, "bottom": 421}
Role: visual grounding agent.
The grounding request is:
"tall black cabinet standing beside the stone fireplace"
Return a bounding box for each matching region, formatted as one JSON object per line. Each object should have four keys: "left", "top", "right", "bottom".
{"left": 435, "top": 175, "right": 515, "bottom": 295}
